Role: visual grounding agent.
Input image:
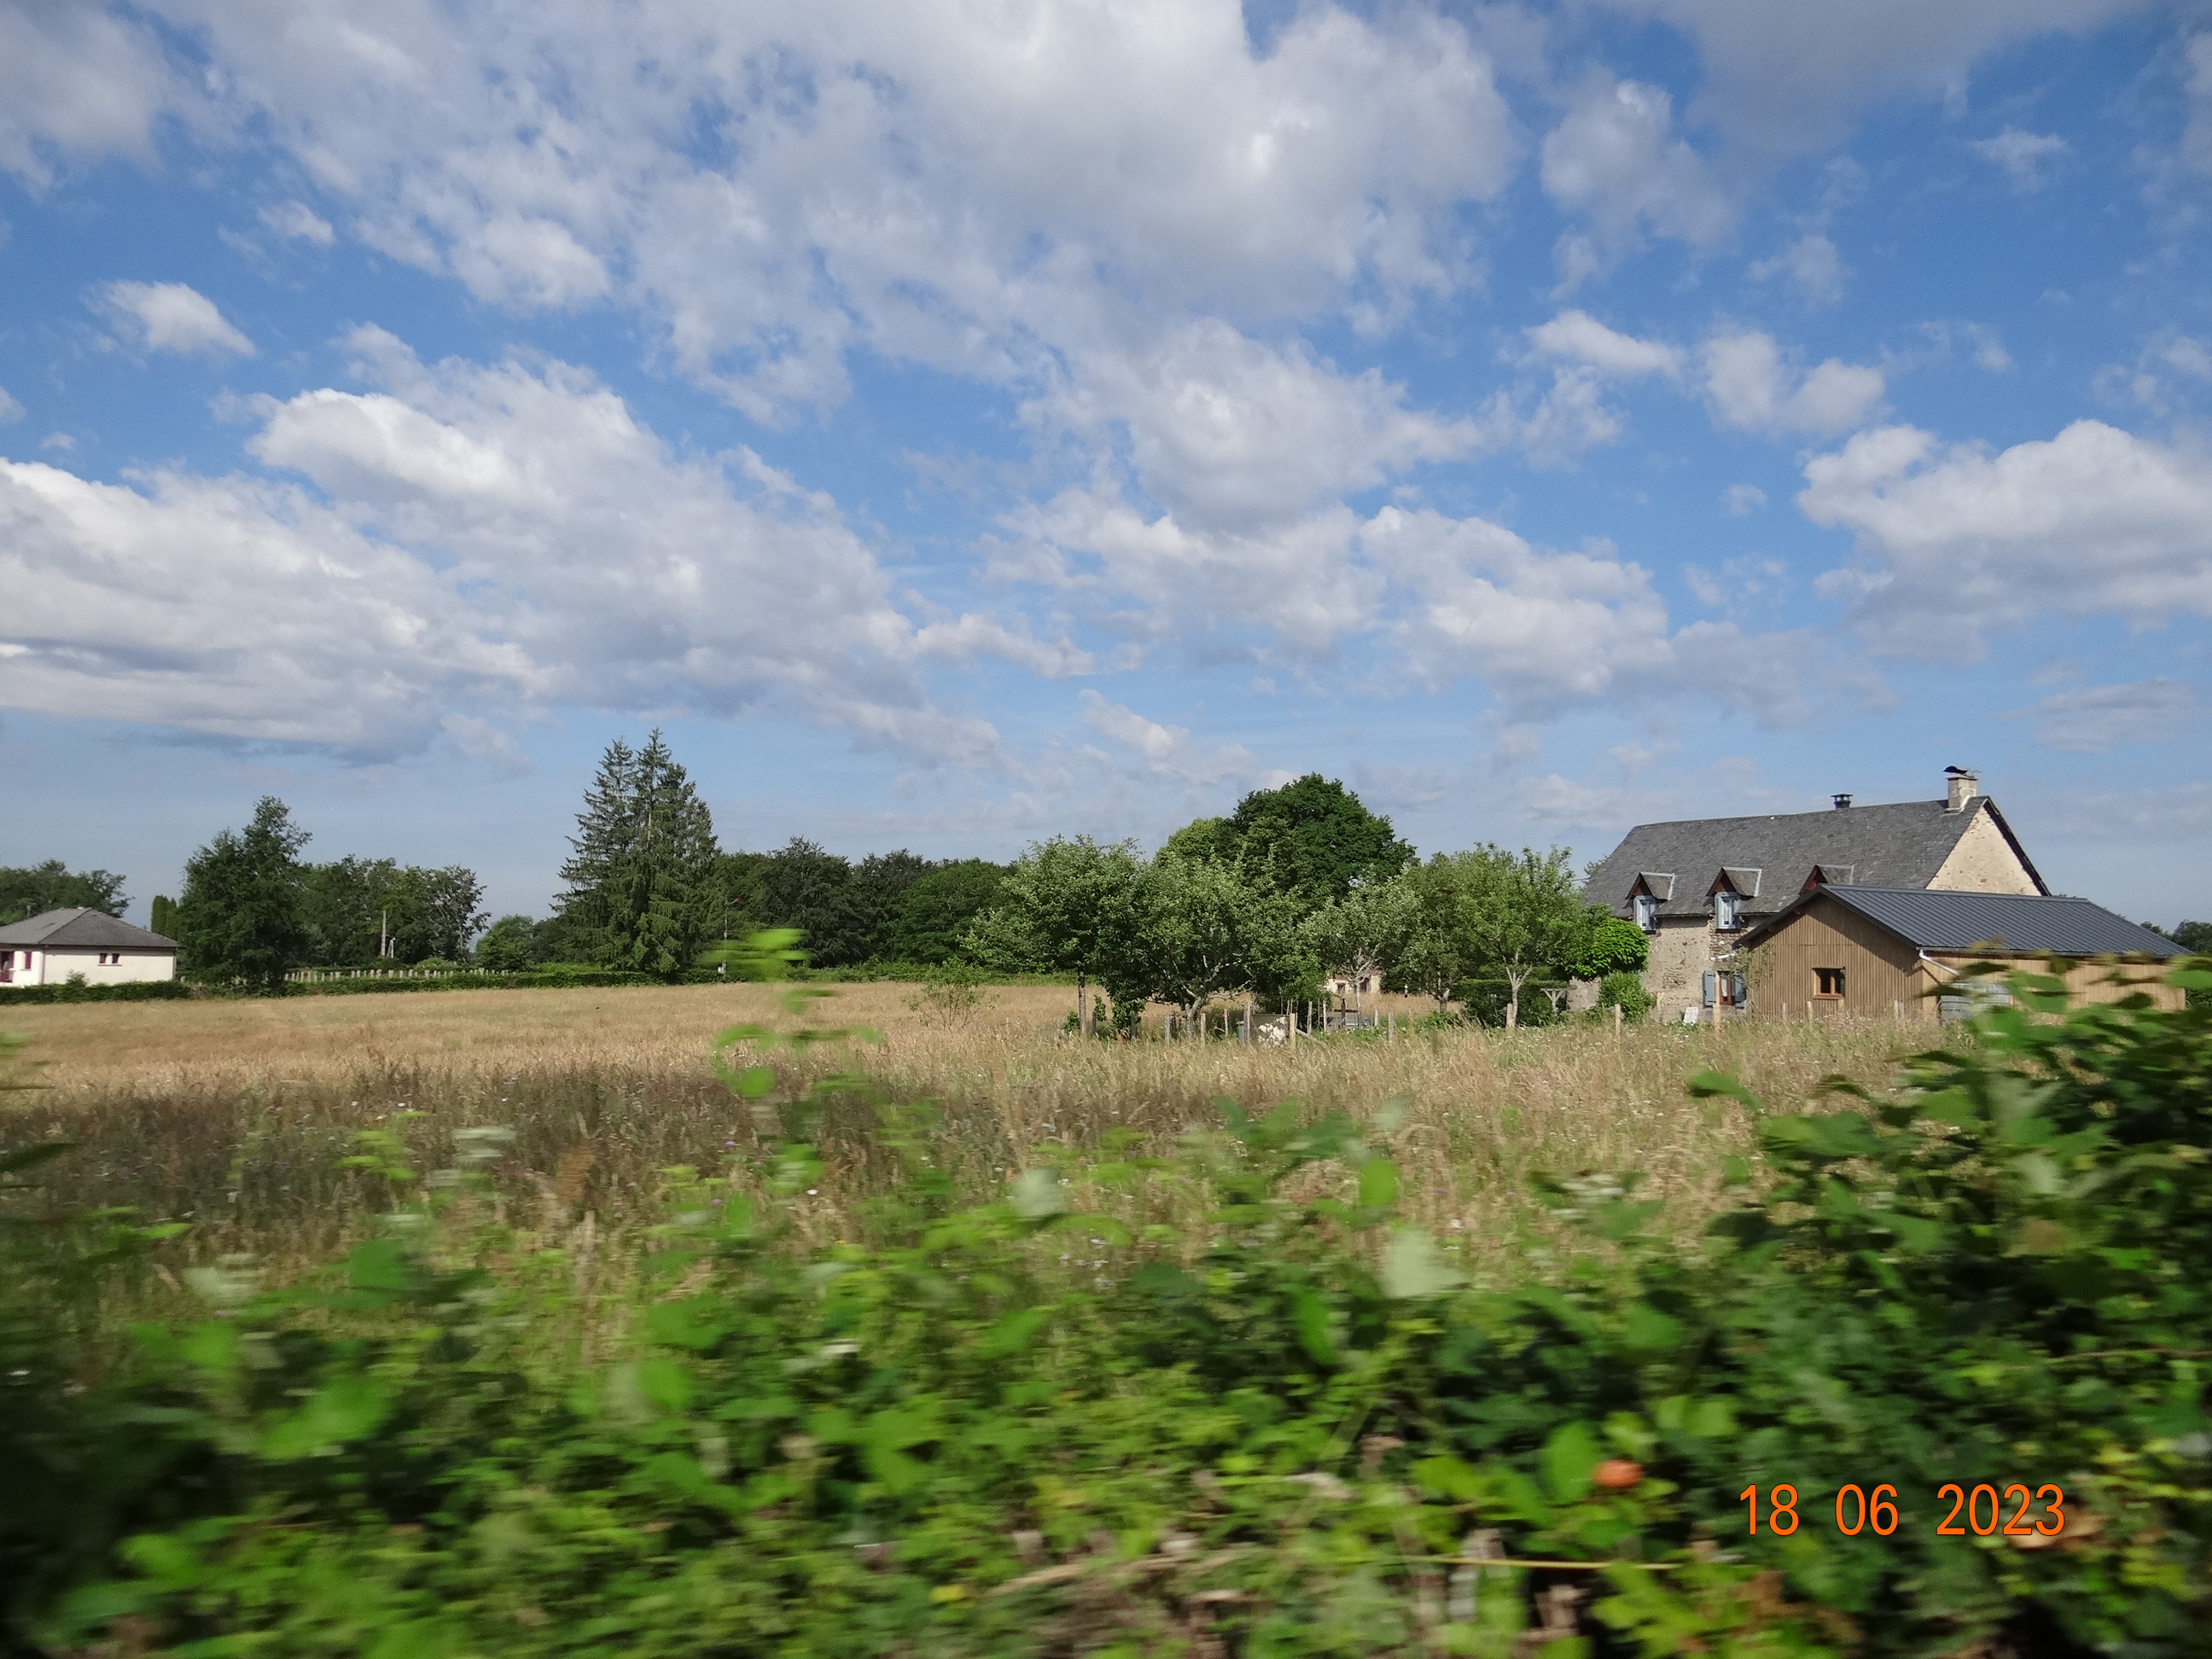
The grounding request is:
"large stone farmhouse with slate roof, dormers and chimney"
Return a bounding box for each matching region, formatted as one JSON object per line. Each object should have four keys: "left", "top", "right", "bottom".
{"left": 1584, "top": 765, "right": 2051, "bottom": 1020}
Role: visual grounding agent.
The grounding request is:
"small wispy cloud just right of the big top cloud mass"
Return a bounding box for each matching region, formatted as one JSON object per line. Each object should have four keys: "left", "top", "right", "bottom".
{"left": 1540, "top": 68, "right": 1737, "bottom": 288}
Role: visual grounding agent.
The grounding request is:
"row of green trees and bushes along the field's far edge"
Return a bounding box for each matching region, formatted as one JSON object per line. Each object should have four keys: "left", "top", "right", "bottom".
{"left": 21, "top": 730, "right": 2212, "bottom": 1008}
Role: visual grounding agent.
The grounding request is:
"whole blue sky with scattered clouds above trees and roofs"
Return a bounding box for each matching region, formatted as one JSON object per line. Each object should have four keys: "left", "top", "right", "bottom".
{"left": 0, "top": 0, "right": 2212, "bottom": 923}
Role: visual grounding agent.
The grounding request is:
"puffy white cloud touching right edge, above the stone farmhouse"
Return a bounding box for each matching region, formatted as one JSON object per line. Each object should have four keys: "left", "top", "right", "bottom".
{"left": 1798, "top": 420, "right": 2212, "bottom": 661}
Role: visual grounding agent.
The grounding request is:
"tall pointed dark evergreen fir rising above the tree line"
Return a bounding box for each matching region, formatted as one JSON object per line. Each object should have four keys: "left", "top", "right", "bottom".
{"left": 560, "top": 730, "right": 721, "bottom": 980}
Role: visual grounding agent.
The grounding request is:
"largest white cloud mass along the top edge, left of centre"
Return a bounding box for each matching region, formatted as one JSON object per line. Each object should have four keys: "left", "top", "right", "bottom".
{"left": 120, "top": 0, "right": 1517, "bottom": 418}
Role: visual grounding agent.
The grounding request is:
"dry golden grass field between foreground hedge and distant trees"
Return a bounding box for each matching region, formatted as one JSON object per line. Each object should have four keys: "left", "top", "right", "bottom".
{"left": 0, "top": 984, "right": 1913, "bottom": 1291}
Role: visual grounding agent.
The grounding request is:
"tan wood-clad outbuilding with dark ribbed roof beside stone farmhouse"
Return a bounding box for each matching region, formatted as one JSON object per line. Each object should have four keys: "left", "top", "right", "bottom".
{"left": 1737, "top": 885, "right": 2186, "bottom": 1022}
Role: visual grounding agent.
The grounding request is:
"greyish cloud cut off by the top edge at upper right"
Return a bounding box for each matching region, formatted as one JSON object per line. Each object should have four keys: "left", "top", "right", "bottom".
{"left": 1606, "top": 0, "right": 2152, "bottom": 153}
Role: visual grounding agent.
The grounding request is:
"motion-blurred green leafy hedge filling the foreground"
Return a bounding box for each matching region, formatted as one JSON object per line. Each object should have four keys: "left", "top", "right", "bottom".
{"left": 0, "top": 964, "right": 2212, "bottom": 1659}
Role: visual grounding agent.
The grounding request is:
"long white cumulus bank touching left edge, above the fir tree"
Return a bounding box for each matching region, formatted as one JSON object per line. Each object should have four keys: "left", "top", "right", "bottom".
{"left": 0, "top": 329, "right": 1017, "bottom": 763}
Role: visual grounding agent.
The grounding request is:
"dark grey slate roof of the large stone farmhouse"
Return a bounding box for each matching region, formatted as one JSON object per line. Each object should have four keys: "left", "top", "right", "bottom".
{"left": 1581, "top": 795, "right": 2051, "bottom": 923}
